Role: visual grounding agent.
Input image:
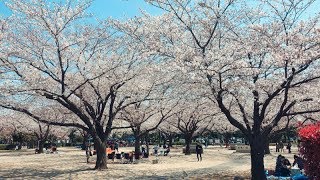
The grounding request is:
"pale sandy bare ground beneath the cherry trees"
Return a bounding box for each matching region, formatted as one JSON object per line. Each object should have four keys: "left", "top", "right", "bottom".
{"left": 0, "top": 146, "right": 297, "bottom": 179}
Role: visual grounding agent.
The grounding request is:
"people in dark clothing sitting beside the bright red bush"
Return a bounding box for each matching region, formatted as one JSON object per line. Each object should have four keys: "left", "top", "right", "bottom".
{"left": 275, "top": 154, "right": 304, "bottom": 177}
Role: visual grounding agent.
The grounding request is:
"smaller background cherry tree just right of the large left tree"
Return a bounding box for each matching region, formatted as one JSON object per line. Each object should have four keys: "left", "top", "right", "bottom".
{"left": 119, "top": 62, "right": 179, "bottom": 159}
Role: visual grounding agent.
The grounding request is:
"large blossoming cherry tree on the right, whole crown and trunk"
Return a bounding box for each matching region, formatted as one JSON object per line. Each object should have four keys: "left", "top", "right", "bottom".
{"left": 118, "top": 0, "right": 320, "bottom": 179}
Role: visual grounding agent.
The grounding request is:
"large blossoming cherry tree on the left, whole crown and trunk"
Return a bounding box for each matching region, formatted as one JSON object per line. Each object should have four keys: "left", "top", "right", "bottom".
{"left": 0, "top": 0, "right": 160, "bottom": 169}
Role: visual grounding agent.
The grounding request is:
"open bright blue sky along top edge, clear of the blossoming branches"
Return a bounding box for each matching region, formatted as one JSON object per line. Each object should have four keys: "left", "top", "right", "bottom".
{"left": 0, "top": 0, "right": 161, "bottom": 19}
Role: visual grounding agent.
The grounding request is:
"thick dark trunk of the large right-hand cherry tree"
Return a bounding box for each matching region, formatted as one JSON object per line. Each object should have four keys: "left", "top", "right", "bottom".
{"left": 249, "top": 135, "right": 267, "bottom": 180}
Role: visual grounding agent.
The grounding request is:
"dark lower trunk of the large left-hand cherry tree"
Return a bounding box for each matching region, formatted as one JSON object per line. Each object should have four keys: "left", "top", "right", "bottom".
{"left": 94, "top": 138, "right": 108, "bottom": 170}
